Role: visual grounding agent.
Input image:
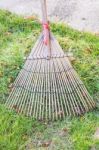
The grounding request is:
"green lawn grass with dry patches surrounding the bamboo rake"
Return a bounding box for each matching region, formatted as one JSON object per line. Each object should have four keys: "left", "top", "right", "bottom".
{"left": 0, "top": 10, "right": 99, "bottom": 150}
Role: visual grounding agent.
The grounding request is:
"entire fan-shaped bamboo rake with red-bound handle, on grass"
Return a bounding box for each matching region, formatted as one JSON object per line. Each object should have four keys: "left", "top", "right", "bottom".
{"left": 6, "top": 0, "right": 95, "bottom": 121}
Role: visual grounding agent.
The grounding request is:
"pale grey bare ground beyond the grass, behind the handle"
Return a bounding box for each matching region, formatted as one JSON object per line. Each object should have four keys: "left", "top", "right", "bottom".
{"left": 0, "top": 0, "right": 99, "bottom": 32}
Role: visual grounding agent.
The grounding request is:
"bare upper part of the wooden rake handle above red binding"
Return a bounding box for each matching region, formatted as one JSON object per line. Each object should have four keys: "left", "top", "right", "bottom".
{"left": 41, "top": 0, "right": 47, "bottom": 23}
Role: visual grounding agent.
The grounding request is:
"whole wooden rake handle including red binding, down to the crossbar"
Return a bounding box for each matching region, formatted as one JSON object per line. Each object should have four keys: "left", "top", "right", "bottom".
{"left": 41, "top": 0, "right": 51, "bottom": 59}
